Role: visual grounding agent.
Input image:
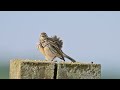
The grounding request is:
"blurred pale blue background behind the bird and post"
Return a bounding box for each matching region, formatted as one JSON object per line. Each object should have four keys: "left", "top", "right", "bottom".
{"left": 0, "top": 11, "right": 120, "bottom": 79}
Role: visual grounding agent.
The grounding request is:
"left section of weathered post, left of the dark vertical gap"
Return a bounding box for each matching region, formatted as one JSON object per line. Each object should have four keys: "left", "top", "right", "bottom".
{"left": 10, "top": 59, "right": 55, "bottom": 79}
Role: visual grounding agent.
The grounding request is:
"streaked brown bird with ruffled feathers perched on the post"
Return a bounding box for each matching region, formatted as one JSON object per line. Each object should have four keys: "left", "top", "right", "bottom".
{"left": 37, "top": 32, "right": 76, "bottom": 62}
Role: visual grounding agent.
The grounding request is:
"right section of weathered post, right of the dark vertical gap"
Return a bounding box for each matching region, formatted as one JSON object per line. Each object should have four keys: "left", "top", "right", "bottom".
{"left": 57, "top": 63, "right": 101, "bottom": 79}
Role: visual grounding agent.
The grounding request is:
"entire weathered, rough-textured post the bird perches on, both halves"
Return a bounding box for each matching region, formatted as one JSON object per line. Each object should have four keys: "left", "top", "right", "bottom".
{"left": 10, "top": 59, "right": 101, "bottom": 79}
